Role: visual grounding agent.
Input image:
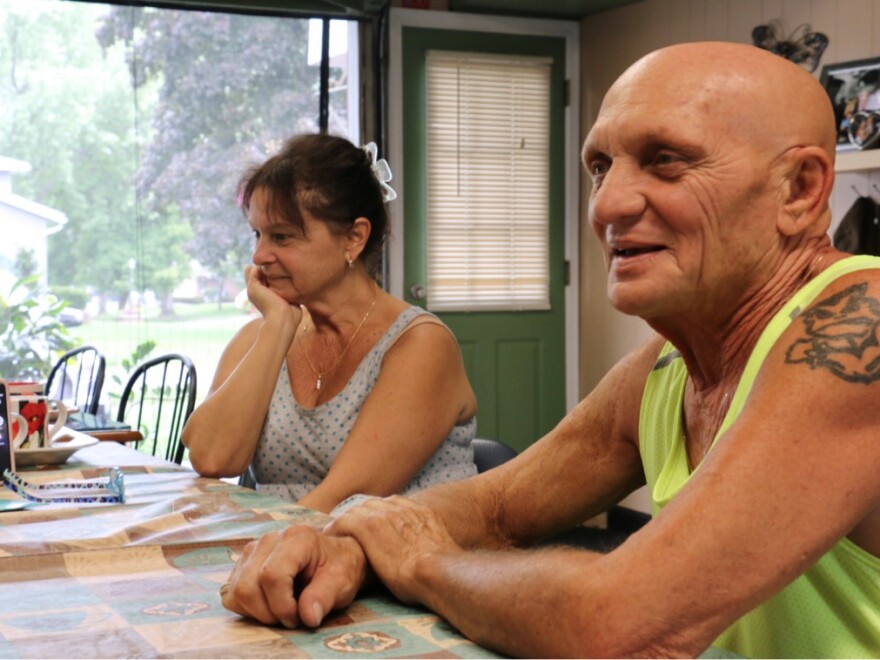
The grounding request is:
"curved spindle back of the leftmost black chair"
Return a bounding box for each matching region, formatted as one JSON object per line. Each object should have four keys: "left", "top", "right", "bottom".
{"left": 45, "top": 346, "right": 107, "bottom": 415}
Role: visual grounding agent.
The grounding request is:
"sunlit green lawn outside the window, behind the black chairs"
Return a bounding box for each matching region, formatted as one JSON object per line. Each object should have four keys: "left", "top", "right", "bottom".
{"left": 70, "top": 303, "right": 251, "bottom": 412}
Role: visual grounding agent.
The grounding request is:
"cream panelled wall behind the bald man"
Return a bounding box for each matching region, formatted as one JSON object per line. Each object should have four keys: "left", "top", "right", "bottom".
{"left": 580, "top": 0, "right": 880, "bottom": 511}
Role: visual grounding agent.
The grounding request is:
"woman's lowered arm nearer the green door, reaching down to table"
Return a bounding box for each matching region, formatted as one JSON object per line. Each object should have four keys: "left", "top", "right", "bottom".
{"left": 300, "top": 323, "right": 476, "bottom": 512}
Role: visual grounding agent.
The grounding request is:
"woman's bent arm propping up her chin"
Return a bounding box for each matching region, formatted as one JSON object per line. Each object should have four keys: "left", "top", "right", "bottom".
{"left": 182, "top": 267, "right": 302, "bottom": 477}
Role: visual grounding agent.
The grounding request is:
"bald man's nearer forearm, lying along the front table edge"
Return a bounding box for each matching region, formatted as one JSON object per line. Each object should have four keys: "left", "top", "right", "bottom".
{"left": 414, "top": 548, "right": 708, "bottom": 658}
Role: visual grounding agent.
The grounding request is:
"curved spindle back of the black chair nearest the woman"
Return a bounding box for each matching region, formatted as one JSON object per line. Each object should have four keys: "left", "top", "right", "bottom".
{"left": 117, "top": 353, "right": 197, "bottom": 465}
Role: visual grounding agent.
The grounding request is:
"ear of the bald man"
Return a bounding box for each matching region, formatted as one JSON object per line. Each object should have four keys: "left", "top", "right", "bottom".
{"left": 776, "top": 147, "right": 834, "bottom": 236}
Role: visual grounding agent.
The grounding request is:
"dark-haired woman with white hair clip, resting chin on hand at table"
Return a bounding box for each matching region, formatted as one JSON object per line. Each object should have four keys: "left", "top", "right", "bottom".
{"left": 183, "top": 135, "right": 476, "bottom": 512}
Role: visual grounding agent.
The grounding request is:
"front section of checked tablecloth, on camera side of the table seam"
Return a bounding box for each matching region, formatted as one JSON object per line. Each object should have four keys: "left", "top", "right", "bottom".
{"left": 0, "top": 541, "right": 497, "bottom": 658}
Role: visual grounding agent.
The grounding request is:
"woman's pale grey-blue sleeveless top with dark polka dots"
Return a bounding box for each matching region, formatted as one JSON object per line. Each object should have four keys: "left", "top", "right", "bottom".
{"left": 251, "top": 307, "right": 477, "bottom": 501}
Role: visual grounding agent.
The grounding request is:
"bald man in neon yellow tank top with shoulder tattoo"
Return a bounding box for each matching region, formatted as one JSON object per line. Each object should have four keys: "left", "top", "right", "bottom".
{"left": 217, "top": 43, "right": 880, "bottom": 657}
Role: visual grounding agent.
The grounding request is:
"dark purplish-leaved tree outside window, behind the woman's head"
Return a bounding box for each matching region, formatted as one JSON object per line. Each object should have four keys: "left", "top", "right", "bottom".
{"left": 98, "top": 7, "right": 328, "bottom": 306}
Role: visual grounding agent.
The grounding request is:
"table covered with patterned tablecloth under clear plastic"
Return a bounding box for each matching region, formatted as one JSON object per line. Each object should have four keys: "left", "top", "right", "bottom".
{"left": 0, "top": 442, "right": 497, "bottom": 658}
